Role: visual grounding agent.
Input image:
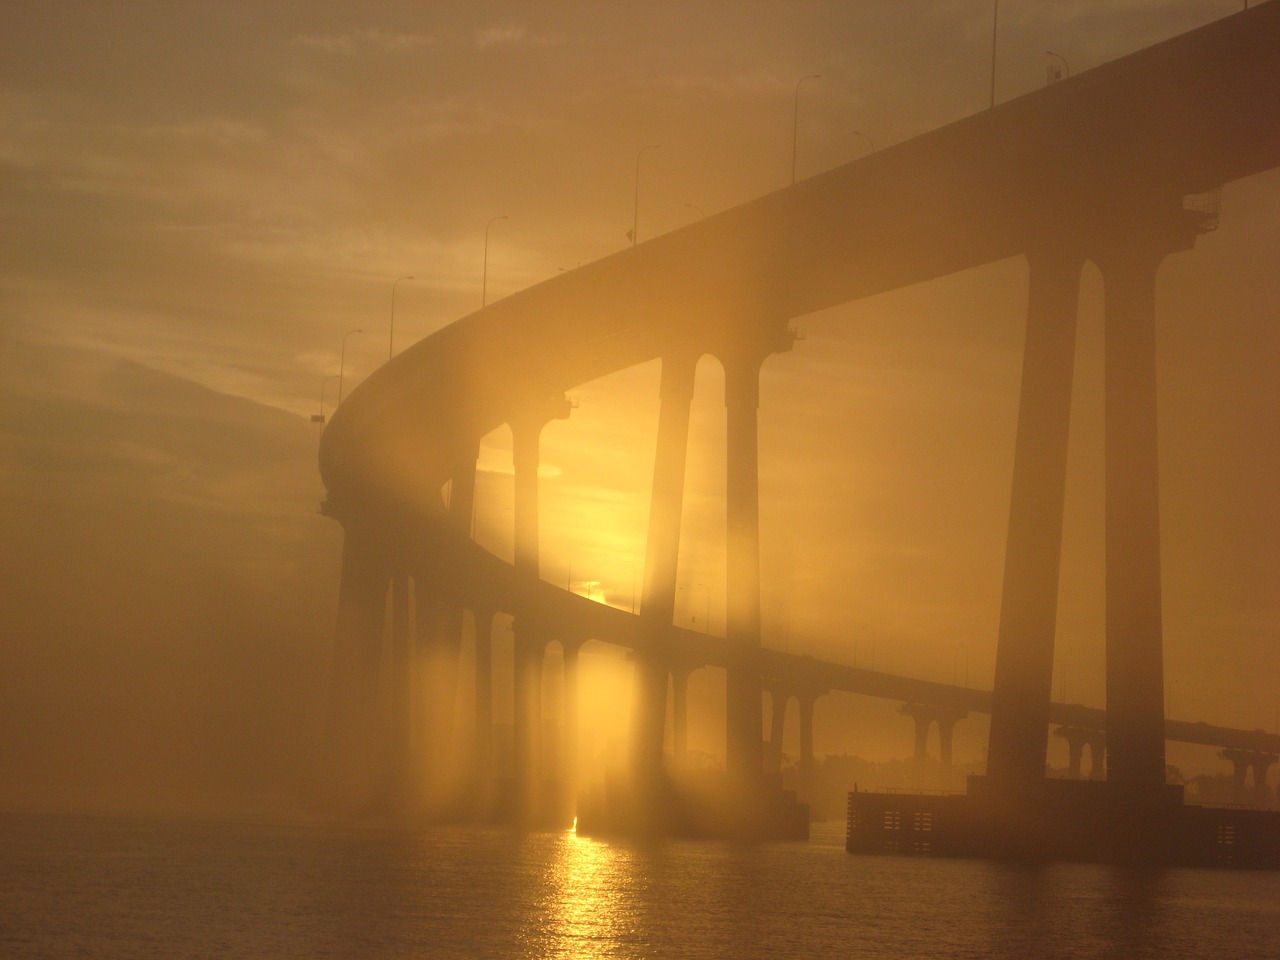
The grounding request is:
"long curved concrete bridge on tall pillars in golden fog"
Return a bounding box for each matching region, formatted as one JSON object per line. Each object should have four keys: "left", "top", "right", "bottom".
{"left": 320, "top": 0, "right": 1280, "bottom": 834}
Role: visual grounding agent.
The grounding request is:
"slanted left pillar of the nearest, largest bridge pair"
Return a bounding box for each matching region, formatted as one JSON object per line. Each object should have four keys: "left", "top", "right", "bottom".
{"left": 987, "top": 244, "right": 1084, "bottom": 783}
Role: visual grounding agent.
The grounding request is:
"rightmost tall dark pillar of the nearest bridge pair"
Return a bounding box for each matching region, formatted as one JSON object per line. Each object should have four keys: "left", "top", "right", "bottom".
{"left": 1094, "top": 204, "right": 1196, "bottom": 804}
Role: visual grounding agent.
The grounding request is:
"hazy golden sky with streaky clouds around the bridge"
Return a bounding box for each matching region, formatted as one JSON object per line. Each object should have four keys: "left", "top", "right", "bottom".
{"left": 0, "top": 0, "right": 1280, "bottom": 805}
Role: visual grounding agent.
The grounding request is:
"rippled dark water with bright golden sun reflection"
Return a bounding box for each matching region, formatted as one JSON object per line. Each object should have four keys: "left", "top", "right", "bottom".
{"left": 0, "top": 814, "right": 1280, "bottom": 960}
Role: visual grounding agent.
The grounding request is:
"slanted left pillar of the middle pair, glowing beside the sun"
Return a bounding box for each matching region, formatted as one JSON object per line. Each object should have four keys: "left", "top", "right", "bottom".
{"left": 631, "top": 353, "right": 698, "bottom": 788}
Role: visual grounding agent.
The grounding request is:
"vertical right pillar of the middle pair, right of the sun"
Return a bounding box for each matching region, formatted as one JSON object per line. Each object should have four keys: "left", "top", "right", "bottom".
{"left": 724, "top": 353, "right": 764, "bottom": 782}
